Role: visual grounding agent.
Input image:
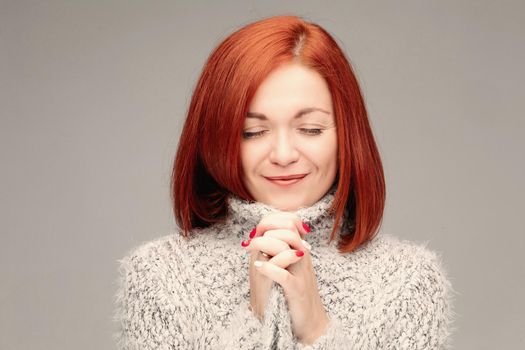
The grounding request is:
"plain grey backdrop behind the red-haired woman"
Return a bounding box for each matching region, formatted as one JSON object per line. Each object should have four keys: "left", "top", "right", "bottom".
{"left": 0, "top": 0, "right": 525, "bottom": 350}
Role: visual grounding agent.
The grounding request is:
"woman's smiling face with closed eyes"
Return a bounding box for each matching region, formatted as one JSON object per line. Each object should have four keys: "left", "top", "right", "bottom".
{"left": 241, "top": 63, "right": 337, "bottom": 211}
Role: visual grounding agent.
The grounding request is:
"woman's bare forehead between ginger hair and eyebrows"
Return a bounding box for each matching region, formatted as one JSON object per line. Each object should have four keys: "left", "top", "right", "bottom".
{"left": 248, "top": 63, "right": 332, "bottom": 117}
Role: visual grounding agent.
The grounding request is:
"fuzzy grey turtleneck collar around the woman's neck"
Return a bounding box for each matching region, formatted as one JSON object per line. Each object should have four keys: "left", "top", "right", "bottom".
{"left": 226, "top": 185, "right": 342, "bottom": 246}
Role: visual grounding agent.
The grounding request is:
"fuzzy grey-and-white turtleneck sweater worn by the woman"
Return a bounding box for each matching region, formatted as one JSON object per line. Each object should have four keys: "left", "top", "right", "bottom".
{"left": 115, "top": 190, "right": 455, "bottom": 350}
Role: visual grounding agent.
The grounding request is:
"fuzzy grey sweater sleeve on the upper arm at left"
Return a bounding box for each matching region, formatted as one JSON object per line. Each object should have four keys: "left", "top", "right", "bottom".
{"left": 114, "top": 249, "right": 195, "bottom": 350}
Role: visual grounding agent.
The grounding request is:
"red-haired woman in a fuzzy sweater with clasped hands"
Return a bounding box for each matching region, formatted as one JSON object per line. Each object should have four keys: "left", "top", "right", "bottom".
{"left": 116, "top": 16, "right": 453, "bottom": 349}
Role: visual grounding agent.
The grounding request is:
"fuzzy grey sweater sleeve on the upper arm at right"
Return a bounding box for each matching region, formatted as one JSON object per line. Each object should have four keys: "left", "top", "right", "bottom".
{"left": 387, "top": 249, "right": 455, "bottom": 349}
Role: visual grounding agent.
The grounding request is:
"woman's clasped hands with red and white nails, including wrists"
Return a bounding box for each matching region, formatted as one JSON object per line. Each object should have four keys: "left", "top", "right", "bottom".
{"left": 243, "top": 212, "right": 329, "bottom": 345}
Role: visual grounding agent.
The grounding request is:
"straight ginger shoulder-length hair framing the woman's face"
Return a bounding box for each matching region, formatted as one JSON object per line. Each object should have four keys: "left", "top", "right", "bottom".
{"left": 171, "top": 16, "right": 386, "bottom": 254}
